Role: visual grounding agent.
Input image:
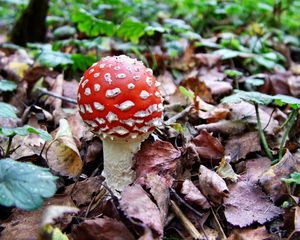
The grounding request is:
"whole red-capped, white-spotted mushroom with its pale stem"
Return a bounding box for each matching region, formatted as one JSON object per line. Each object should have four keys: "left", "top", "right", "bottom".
{"left": 77, "top": 55, "right": 163, "bottom": 193}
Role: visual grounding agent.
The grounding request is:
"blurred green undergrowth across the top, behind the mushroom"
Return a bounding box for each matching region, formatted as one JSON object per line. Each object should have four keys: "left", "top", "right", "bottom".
{"left": 0, "top": 0, "right": 300, "bottom": 73}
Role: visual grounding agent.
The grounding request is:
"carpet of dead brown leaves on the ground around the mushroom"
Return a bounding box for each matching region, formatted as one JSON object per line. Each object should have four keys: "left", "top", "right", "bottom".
{"left": 0, "top": 1, "right": 300, "bottom": 240}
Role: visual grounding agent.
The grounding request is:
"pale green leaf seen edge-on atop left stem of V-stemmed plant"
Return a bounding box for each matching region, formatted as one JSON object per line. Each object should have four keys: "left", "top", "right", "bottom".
{"left": 221, "top": 90, "right": 273, "bottom": 105}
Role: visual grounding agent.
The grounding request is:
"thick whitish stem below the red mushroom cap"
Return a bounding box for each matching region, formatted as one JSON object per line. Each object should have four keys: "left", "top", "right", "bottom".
{"left": 102, "top": 138, "right": 141, "bottom": 196}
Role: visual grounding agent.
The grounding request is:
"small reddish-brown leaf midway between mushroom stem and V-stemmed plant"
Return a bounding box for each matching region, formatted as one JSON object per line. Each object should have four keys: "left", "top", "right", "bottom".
{"left": 191, "top": 130, "right": 224, "bottom": 164}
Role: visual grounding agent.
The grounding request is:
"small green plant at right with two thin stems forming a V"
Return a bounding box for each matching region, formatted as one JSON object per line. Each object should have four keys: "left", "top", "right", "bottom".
{"left": 222, "top": 90, "right": 300, "bottom": 164}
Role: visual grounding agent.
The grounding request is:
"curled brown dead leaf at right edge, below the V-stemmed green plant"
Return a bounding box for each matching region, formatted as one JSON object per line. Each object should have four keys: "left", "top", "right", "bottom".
{"left": 259, "top": 150, "right": 300, "bottom": 202}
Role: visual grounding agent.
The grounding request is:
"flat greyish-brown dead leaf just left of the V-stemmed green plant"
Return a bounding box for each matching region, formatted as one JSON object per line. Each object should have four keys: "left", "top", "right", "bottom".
{"left": 225, "top": 132, "right": 261, "bottom": 162}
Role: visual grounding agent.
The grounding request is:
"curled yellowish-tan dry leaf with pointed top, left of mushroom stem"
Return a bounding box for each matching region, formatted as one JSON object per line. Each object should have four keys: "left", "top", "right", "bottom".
{"left": 45, "top": 119, "right": 83, "bottom": 177}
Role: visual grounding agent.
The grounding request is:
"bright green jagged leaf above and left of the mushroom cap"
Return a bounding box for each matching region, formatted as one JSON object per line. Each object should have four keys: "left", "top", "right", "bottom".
{"left": 71, "top": 9, "right": 116, "bottom": 37}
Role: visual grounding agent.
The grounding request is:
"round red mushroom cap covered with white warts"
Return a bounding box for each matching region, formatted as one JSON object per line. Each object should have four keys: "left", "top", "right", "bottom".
{"left": 77, "top": 55, "right": 163, "bottom": 141}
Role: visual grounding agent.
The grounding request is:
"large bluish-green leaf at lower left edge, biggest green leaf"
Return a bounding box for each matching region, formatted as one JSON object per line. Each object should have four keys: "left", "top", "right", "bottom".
{"left": 0, "top": 158, "right": 56, "bottom": 210}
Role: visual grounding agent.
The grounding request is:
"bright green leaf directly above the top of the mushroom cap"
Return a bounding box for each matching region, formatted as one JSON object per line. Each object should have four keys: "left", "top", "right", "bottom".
{"left": 117, "top": 18, "right": 147, "bottom": 43}
